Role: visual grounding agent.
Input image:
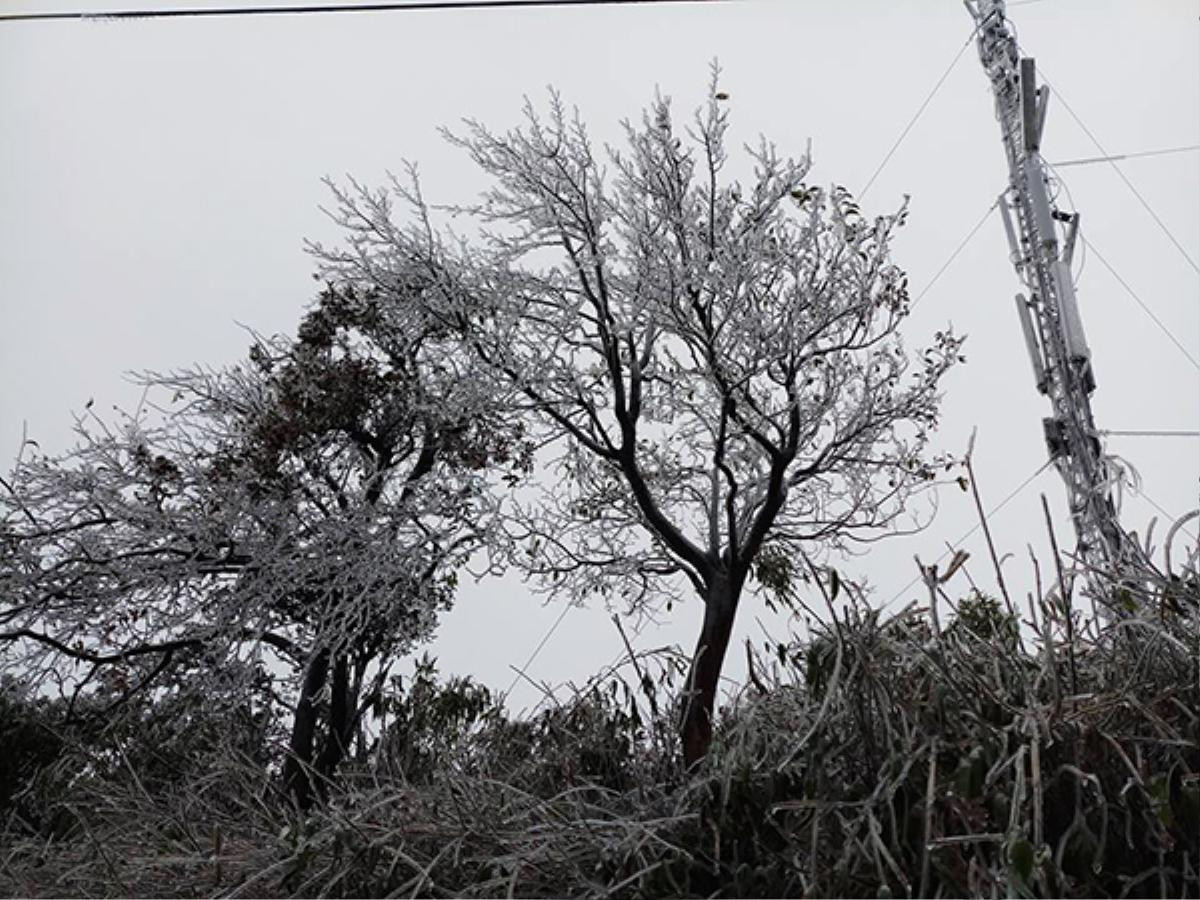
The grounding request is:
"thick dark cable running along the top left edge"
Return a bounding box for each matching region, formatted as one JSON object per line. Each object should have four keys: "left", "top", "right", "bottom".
{"left": 0, "top": 0, "right": 731, "bottom": 22}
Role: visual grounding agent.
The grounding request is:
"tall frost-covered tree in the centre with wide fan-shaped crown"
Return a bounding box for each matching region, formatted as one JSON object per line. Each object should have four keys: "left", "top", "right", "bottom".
{"left": 317, "top": 76, "right": 960, "bottom": 763}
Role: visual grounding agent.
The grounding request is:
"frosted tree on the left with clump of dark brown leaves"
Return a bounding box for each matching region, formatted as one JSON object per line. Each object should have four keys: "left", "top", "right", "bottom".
{"left": 0, "top": 288, "right": 528, "bottom": 805}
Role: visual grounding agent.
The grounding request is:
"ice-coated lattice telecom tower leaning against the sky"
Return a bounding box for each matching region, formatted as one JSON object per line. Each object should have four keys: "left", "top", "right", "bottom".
{"left": 964, "top": 0, "right": 1147, "bottom": 607}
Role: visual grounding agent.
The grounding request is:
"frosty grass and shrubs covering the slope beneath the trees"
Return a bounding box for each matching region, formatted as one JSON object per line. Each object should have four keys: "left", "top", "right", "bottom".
{"left": 0, "top": 582, "right": 1200, "bottom": 896}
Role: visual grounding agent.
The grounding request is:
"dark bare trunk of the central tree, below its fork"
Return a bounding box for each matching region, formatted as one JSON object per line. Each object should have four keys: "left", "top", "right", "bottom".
{"left": 679, "top": 572, "right": 743, "bottom": 768}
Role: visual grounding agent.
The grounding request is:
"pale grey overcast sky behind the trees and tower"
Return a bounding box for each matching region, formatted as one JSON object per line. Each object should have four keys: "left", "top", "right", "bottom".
{"left": 0, "top": 0, "right": 1200, "bottom": 720}
